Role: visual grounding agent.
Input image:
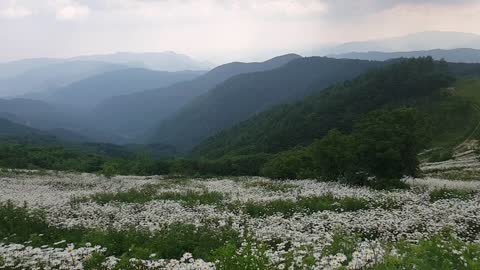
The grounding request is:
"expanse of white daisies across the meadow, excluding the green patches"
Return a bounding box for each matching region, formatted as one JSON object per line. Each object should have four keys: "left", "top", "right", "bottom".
{"left": 0, "top": 171, "right": 480, "bottom": 269}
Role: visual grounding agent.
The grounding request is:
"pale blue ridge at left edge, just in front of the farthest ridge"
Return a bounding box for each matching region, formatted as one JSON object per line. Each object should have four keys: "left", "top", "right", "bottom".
{"left": 0, "top": 61, "right": 125, "bottom": 97}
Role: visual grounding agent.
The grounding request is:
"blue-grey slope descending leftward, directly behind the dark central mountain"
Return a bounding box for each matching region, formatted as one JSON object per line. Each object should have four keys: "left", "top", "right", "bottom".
{"left": 92, "top": 54, "right": 300, "bottom": 138}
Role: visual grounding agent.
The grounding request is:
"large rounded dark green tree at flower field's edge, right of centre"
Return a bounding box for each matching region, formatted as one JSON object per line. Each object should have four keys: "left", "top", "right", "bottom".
{"left": 353, "top": 108, "right": 430, "bottom": 179}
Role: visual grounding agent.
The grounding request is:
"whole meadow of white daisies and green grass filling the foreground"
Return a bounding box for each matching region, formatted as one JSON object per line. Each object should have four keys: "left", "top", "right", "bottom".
{"left": 0, "top": 165, "right": 480, "bottom": 269}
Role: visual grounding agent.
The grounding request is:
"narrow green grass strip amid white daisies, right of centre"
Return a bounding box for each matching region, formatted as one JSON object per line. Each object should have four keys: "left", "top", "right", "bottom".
{"left": 243, "top": 194, "right": 369, "bottom": 217}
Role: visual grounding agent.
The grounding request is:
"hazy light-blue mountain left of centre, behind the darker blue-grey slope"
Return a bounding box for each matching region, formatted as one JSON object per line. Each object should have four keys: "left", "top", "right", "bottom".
{"left": 29, "top": 68, "right": 204, "bottom": 110}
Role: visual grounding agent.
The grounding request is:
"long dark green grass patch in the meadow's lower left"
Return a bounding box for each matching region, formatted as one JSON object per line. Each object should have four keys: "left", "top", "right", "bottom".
{"left": 0, "top": 202, "right": 239, "bottom": 264}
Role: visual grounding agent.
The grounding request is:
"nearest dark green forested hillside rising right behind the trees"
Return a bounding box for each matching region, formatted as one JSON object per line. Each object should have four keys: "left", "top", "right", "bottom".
{"left": 194, "top": 58, "right": 453, "bottom": 158}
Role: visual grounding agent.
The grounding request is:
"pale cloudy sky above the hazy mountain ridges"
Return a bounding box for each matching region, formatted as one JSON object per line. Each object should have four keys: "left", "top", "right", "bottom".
{"left": 0, "top": 0, "right": 480, "bottom": 63}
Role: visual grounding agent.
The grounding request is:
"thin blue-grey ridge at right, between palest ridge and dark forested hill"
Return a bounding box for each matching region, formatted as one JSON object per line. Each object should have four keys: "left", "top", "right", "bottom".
{"left": 330, "top": 49, "right": 480, "bottom": 63}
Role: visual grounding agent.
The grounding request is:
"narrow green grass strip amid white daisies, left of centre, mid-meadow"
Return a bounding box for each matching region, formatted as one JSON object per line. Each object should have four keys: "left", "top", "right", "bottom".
{"left": 72, "top": 185, "right": 224, "bottom": 207}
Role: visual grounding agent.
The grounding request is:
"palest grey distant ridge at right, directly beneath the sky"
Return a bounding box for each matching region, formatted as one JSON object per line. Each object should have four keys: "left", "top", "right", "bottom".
{"left": 317, "top": 31, "right": 480, "bottom": 55}
